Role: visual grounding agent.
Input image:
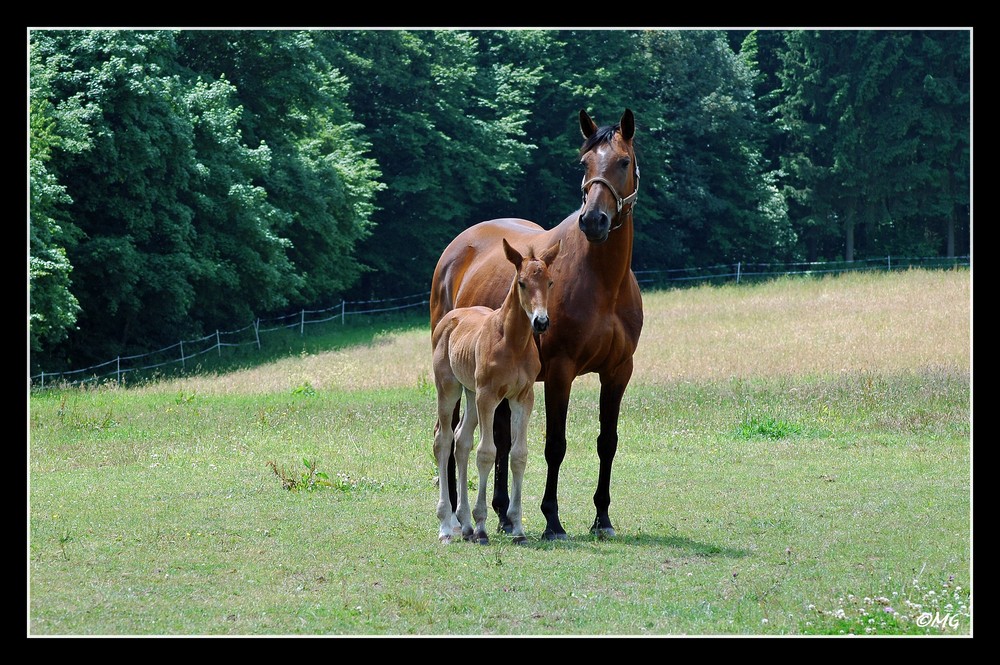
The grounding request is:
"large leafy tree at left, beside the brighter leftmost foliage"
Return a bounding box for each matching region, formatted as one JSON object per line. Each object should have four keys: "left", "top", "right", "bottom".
{"left": 31, "top": 30, "right": 289, "bottom": 364}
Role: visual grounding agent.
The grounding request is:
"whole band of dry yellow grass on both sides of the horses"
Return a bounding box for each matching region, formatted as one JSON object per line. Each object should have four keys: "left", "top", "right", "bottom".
{"left": 141, "top": 270, "right": 972, "bottom": 394}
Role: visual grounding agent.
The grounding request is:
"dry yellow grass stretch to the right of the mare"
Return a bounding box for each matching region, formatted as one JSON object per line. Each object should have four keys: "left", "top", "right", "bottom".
{"left": 633, "top": 270, "right": 972, "bottom": 383}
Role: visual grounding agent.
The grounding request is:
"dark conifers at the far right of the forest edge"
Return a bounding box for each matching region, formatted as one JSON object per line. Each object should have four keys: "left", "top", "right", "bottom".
{"left": 777, "top": 30, "right": 969, "bottom": 261}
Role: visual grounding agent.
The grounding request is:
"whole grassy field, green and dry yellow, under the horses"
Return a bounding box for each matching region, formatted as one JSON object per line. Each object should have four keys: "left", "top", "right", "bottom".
{"left": 27, "top": 270, "right": 973, "bottom": 636}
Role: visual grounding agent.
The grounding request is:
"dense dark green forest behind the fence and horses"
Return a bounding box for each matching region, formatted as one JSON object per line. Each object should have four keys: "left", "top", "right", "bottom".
{"left": 28, "top": 30, "right": 971, "bottom": 371}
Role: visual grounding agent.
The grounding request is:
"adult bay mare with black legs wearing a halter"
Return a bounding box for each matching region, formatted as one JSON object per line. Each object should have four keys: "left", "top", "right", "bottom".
{"left": 430, "top": 109, "right": 642, "bottom": 539}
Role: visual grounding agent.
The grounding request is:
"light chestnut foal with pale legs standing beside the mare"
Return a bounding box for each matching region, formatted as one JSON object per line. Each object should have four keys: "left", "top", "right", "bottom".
{"left": 431, "top": 239, "right": 559, "bottom": 545}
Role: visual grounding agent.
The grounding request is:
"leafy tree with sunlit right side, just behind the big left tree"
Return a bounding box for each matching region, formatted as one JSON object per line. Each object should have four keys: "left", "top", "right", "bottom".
{"left": 178, "top": 30, "right": 384, "bottom": 309}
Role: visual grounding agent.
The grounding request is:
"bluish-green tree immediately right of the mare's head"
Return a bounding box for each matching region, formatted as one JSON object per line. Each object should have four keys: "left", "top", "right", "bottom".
{"left": 636, "top": 30, "right": 795, "bottom": 267}
